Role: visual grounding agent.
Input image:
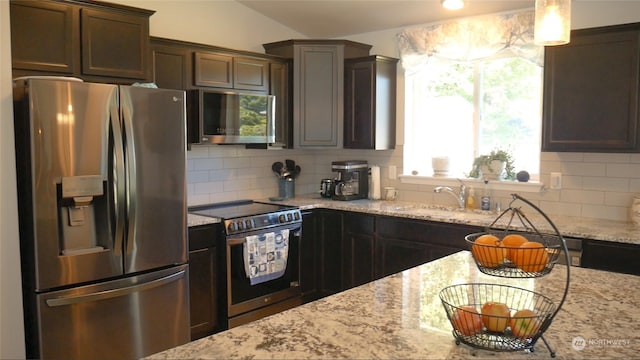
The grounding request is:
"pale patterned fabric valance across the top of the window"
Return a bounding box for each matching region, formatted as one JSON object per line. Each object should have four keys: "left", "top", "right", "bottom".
{"left": 397, "top": 10, "right": 544, "bottom": 69}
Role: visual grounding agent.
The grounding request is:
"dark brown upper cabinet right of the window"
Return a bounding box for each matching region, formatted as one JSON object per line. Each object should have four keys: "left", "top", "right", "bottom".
{"left": 542, "top": 23, "right": 640, "bottom": 152}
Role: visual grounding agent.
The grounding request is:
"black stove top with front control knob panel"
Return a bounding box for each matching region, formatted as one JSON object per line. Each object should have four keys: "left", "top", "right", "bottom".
{"left": 189, "top": 200, "right": 302, "bottom": 235}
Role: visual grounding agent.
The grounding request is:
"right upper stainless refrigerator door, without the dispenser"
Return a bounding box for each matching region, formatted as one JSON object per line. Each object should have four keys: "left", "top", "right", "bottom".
{"left": 120, "top": 86, "right": 187, "bottom": 273}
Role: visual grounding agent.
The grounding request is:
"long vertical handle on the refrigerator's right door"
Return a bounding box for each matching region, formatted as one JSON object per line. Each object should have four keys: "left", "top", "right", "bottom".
{"left": 120, "top": 93, "right": 138, "bottom": 254}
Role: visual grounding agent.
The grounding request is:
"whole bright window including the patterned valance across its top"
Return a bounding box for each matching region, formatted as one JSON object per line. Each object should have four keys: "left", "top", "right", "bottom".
{"left": 398, "top": 10, "right": 544, "bottom": 180}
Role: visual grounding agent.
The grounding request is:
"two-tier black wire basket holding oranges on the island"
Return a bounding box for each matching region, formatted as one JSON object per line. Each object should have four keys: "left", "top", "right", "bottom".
{"left": 440, "top": 194, "right": 570, "bottom": 357}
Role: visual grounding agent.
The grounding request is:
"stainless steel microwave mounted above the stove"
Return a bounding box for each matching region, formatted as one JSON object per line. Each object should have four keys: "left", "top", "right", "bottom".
{"left": 187, "top": 90, "right": 276, "bottom": 144}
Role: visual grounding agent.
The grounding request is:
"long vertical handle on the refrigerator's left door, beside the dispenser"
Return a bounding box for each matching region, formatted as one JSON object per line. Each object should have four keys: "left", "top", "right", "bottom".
{"left": 110, "top": 105, "right": 126, "bottom": 256}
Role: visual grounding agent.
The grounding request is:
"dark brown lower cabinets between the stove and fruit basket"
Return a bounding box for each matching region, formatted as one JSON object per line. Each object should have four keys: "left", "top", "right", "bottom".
{"left": 300, "top": 209, "right": 482, "bottom": 302}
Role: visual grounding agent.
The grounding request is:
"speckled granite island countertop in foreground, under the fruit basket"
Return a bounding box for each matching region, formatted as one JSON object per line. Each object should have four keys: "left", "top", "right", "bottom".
{"left": 149, "top": 251, "right": 640, "bottom": 359}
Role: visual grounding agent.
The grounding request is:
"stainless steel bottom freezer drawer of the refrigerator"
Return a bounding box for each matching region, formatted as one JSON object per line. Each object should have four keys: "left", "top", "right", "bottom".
{"left": 31, "top": 265, "right": 190, "bottom": 359}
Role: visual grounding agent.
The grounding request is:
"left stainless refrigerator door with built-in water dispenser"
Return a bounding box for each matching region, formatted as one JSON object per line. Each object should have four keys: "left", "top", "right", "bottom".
{"left": 14, "top": 79, "right": 124, "bottom": 291}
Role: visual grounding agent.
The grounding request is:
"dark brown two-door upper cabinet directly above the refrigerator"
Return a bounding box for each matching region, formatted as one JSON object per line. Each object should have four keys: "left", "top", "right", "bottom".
{"left": 10, "top": 0, "right": 154, "bottom": 83}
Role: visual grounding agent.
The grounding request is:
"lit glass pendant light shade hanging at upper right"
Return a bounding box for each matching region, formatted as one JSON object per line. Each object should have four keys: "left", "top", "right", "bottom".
{"left": 534, "top": 0, "right": 571, "bottom": 46}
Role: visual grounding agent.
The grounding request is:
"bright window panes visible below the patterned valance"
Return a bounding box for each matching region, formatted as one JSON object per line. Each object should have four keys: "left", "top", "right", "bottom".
{"left": 404, "top": 57, "right": 542, "bottom": 177}
